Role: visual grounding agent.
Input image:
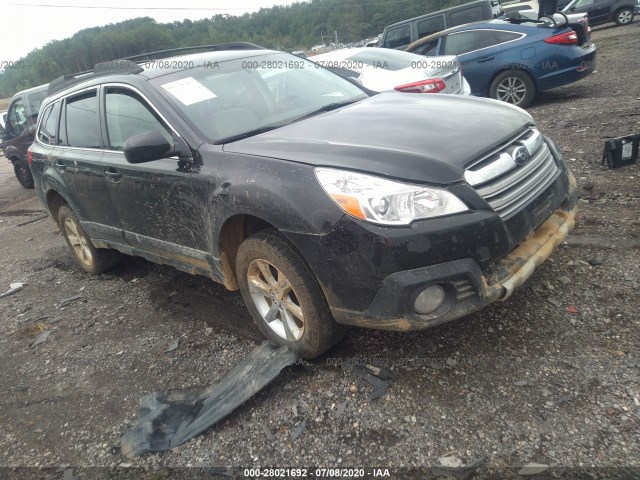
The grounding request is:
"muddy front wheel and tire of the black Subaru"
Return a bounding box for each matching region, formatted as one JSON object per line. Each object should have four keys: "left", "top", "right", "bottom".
{"left": 236, "top": 230, "right": 345, "bottom": 359}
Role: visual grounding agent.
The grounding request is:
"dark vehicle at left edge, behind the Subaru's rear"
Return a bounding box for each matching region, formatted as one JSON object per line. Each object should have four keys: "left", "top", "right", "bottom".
{"left": 0, "top": 85, "right": 47, "bottom": 188}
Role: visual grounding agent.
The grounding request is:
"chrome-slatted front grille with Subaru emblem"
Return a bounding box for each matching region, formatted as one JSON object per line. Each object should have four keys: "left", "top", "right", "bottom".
{"left": 465, "top": 128, "right": 559, "bottom": 220}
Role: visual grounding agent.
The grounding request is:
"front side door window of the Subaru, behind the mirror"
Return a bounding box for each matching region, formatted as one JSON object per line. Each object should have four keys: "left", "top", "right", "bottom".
{"left": 105, "top": 88, "right": 173, "bottom": 150}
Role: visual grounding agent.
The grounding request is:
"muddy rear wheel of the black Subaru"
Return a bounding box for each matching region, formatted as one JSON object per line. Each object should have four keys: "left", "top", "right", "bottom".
{"left": 58, "top": 205, "right": 122, "bottom": 275}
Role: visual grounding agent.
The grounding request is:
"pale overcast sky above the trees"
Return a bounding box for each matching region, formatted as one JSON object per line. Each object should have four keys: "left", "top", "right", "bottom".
{"left": 0, "top": 0, "right": 293, "bottom": 62}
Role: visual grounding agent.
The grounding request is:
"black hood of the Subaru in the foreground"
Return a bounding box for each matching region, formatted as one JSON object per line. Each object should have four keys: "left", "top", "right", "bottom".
{"left": 224, "top": 93, "right": 533, "bottom": 184}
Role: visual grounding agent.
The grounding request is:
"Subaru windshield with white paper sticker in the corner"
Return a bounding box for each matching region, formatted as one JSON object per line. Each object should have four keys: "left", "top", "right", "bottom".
{"left": 151, "top": 53, "right": 367, "bottom": 143}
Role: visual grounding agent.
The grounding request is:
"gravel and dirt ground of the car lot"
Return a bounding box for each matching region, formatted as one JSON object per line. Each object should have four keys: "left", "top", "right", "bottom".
{"left": 0, "top": 21, "right": 640, "bottom": 479}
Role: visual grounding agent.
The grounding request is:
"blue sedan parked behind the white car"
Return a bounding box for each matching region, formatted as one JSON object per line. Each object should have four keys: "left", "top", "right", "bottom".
{"left": 406, "top": 18, "right": 596, "bottom": 107}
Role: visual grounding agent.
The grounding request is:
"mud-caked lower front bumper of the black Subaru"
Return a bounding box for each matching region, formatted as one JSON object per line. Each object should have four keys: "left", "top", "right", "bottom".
{"left": 331, "top": 174, "right": 578, "bottom": 331}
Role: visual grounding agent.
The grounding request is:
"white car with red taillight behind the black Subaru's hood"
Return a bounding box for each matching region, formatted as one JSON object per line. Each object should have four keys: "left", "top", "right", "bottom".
{"left": 309, "top": 47, "right": 471, "bottom": 95}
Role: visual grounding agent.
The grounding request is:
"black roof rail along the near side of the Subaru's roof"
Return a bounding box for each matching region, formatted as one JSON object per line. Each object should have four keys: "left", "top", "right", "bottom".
{"left": 47, "top": 42, "right": 264, "bottom": 97}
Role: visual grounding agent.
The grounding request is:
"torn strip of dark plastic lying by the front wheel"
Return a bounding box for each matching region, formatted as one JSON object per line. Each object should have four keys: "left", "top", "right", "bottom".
{"left": 120, "top": 342, "right": 304, "bottom": 457}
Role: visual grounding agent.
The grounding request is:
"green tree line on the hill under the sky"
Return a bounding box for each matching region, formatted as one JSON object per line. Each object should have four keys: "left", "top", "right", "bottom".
{"left": 0, "top": 0, "right": 465, "bottom": 98}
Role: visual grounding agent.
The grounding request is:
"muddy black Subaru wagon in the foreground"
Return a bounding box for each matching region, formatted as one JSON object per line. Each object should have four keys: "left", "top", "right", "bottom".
{"left": 30, "top": 44, "right": 576, "bottom": 358}
